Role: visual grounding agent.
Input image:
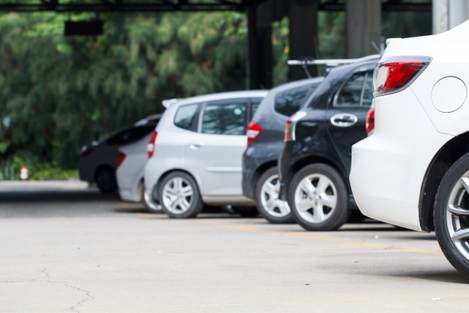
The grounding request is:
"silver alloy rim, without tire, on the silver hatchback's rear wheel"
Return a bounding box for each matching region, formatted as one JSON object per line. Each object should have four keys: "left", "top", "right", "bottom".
{"left": 162, "top": 177, "right": 194, "bottom": 214}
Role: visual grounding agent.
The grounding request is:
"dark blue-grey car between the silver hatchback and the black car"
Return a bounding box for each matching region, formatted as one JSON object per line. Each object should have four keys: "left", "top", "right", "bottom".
{"left": 242, "top": 78, "right": 322, "bottom": 223}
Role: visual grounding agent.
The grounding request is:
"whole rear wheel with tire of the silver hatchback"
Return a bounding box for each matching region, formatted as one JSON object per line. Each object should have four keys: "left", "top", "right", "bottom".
{"left": 158, "top": 171, "right": 203, "bottom": 219}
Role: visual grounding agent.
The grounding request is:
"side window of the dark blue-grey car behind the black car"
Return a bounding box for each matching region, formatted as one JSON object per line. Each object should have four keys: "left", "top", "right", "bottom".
{"left": 274, "top": 85, "right": 313, "bottom": 116}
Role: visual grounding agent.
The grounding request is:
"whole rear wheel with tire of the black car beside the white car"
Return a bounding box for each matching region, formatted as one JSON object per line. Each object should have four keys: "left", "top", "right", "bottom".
{"left": 288, "top": 163, "right": 350, "bottom": 231}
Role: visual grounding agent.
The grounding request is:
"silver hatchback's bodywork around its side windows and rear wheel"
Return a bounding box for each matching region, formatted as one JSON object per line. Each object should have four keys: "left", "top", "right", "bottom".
{"left": 145, "top": 91, "right": 267, "bottom": 204}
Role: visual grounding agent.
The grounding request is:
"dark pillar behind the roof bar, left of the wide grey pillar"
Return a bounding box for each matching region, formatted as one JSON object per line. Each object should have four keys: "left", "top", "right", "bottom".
{"left": 288, "top": 0, "right": 319, "bottom": 80}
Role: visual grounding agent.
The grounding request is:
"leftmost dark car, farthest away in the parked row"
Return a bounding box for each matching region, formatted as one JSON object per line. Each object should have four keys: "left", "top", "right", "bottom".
{"left": 78, "top": 115, "right": 160, "bottom": 193}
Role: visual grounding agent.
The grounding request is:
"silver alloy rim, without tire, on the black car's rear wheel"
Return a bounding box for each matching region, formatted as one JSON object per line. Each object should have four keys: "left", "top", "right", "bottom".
{"left": 294, "top": 174, "right": 337, "bottom": 223}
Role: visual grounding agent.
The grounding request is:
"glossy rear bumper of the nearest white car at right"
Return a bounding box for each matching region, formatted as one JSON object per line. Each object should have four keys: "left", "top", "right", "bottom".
{"left": 350, "top": 90, "right": 450, "bottom": 230}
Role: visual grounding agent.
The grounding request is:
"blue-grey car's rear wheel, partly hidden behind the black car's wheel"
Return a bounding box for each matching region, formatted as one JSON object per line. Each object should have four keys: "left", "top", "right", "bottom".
{"left": 256, "top": 167, "right": 294, "bottom": 224}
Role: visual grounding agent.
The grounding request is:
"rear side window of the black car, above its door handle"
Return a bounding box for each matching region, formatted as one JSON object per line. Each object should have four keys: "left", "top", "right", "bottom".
{"left": 335, "top": 71, "right": 373, "bottom": 106}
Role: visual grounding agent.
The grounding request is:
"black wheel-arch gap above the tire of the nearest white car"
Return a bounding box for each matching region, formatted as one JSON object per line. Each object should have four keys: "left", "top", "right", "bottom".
{"left": 419, "top": 132, "right": 469, "bottom": 231}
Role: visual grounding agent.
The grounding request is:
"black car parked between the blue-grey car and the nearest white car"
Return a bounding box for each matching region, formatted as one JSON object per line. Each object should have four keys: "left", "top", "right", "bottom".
{"left": 279, "top": 61, "right": 376, "bottom": 230}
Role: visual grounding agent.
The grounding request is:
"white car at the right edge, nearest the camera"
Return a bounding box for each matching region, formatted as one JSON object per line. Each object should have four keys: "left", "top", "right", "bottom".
{"left": 350, "top": 22, "right": 469, "bottom": 276}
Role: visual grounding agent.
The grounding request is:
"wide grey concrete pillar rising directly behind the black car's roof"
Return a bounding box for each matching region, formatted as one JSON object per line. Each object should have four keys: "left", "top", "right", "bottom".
{"left": 345, "top": 0, "right": 381, "bottom": 58}
